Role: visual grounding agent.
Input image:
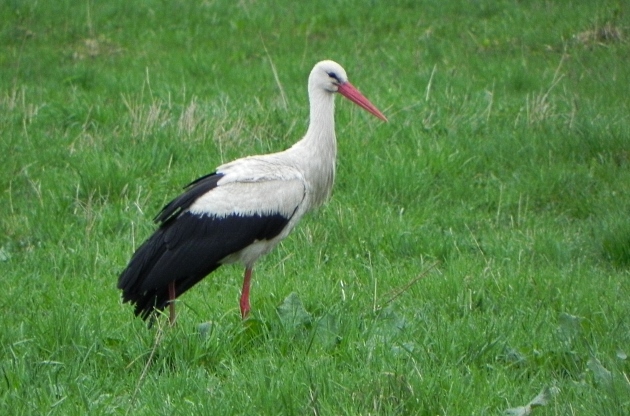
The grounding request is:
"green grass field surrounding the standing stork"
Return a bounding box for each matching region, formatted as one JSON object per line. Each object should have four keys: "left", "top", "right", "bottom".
{"left": 0, "top": 0, "right": 630, "bottom": 416}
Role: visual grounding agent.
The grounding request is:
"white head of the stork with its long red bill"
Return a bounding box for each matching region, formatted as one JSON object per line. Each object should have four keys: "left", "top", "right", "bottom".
{"left": 308, "top": 61, "right": 387, "bottom": 121}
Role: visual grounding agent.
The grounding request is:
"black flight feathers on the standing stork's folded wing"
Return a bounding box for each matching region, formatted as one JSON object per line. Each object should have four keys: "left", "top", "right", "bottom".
{"left": 118, "top": 174, "right": 290, "bottom": 319}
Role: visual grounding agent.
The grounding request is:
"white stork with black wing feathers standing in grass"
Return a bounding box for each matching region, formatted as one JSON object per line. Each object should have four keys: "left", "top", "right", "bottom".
{"left": 118, "top": 61, "right": 387, "bottom": 324}
